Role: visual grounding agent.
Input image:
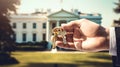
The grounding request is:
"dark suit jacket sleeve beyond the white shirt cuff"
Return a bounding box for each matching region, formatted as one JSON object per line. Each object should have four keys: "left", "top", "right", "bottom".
{"left": 114, "top": 27, "right": 120, "bottom": 67}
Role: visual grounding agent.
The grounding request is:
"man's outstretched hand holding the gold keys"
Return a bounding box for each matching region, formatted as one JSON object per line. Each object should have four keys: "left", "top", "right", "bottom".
{"left": 53, "top": 19, "right": 109, "bottom": 51}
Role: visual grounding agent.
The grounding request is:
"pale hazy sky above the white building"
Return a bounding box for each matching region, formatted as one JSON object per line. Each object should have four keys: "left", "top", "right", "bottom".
{"left": 18, "top": 0, "right": 120, "bottom": 27}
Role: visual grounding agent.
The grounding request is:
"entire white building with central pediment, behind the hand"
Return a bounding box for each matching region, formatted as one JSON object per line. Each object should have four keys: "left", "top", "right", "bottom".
{"left": 11, "top": 9, "right": 102, "bottom": 43}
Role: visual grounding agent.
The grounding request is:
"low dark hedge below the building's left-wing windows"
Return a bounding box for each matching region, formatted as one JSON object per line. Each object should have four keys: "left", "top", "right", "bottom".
{"left": 16, "top": 41, "right": 48, "bottom": 51}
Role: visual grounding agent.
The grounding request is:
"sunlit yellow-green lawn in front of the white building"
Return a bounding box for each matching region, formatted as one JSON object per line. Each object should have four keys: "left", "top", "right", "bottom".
{"left": 0, "top": 52, "right": 112, "bottom": 67}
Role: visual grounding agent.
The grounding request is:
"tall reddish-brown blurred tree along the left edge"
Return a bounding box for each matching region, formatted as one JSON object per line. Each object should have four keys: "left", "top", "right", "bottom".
{"left": 0, "top": 0, "right": 20, "bottom": 51}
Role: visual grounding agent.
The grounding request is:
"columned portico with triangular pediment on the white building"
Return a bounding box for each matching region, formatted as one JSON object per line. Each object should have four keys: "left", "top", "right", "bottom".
{"left": 46, "top": 9, "right": 79, "bottom": 41}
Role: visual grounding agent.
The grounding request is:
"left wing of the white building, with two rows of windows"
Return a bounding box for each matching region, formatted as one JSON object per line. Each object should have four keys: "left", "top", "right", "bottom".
{"left": 11, "top": 14, "right": 47, "bottom": 43}
